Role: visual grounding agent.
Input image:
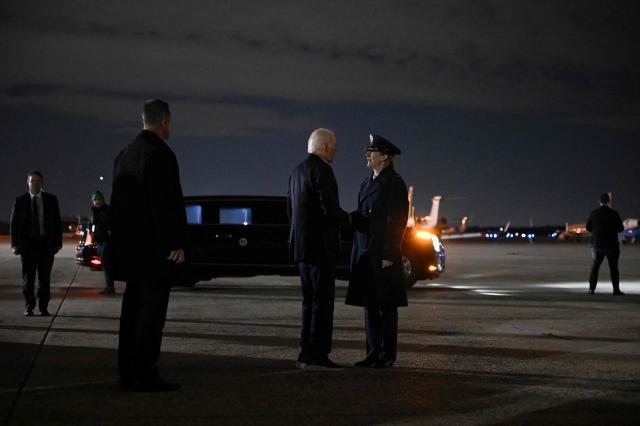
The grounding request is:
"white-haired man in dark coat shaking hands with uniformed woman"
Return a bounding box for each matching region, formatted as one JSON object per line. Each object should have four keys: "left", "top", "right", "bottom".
{"left": 287, "top": 129, "right": 350, "bottom": 369}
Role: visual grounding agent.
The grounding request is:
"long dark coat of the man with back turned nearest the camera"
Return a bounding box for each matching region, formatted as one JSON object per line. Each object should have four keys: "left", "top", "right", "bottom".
{"left": 111, "top": 130, "right": 187, "bottom": 284}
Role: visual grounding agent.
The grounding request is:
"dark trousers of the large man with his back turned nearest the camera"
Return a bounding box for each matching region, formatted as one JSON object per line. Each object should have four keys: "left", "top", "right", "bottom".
{"left": 118, "top": 283, "right": 171, "bottom": 384}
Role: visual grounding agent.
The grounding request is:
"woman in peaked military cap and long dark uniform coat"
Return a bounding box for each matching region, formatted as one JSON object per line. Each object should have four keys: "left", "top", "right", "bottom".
{"left": 346, "top": 134, "right": 409, "bottom": 368}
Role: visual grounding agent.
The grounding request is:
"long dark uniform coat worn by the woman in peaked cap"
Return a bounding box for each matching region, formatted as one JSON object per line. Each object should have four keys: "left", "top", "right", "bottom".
{"left": 346, "top": 167, "right": 409, "bottom": 308}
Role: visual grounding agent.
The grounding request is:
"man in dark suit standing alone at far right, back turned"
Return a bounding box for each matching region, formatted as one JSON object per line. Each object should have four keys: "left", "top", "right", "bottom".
{"left": 587, "top": 193, "right": 624, "bottom": 296}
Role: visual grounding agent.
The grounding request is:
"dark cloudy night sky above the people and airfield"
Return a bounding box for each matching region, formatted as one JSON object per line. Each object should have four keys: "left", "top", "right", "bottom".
{"left": 0, "top": 0, "right": 640, "bottom": 225}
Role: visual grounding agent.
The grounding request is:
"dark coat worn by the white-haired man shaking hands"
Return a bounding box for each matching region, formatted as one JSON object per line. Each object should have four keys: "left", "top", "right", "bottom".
{"left": 287, "top": 154, "right": 349, "bottom": 263}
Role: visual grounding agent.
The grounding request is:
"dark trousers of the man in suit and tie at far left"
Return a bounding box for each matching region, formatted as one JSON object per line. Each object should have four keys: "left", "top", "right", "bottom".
{"left": 20, "top": 237, "right": 55, "bottom": 311}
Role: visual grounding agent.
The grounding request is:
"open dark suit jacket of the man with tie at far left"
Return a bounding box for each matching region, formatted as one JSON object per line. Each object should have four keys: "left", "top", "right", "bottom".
{"left": 11, "top": 192, "right": 62, "bottom": 252}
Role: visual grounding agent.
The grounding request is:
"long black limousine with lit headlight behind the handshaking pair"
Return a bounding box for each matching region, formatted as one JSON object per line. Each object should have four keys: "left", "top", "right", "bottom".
{"left": 180, "top": 196, "right": 445, "bottom": 288}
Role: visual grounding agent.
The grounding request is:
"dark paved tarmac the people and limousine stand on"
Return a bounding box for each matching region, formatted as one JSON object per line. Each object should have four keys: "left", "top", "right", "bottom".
{"left": 0, "top": 241, "right": 640, "bottom": 425}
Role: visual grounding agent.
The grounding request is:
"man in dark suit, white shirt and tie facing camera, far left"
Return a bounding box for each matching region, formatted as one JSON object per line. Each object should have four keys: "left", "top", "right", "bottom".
{"left": 11, "top": 170, "right": 62, "bottom": 317}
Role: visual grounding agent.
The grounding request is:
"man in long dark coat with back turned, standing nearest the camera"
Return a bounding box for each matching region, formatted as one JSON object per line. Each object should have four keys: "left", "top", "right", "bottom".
{"left": 111, "top": 99, "right": 187, "bottom": 392}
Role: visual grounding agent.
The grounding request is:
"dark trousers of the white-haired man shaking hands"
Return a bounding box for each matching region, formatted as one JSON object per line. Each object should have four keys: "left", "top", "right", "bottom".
{"left": 298, "top": 262, "right": 336, "bottom": 361}
